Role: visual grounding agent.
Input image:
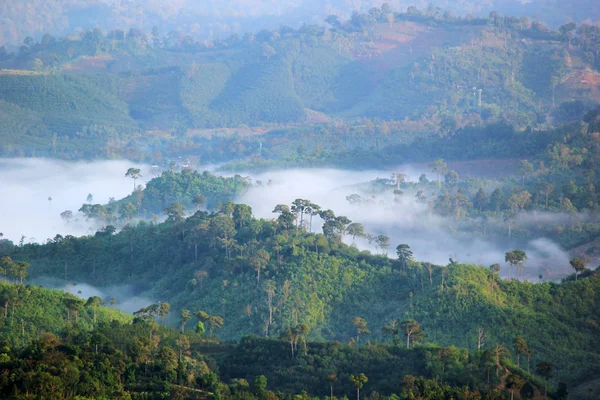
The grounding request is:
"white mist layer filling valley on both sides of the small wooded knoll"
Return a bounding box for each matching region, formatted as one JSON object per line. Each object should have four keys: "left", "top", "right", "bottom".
{"left": 0, "top": 159, "right": 570, "bottom": 280}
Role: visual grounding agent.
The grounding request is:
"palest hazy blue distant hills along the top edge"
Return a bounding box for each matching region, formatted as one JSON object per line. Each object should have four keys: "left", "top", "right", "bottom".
{"left": 0, "top": 0, "right": 600, "bottom": 45}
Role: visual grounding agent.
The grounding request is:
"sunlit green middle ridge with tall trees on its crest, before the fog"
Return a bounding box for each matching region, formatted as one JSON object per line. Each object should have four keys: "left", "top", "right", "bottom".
{"left": 3, "top": 192, "right": 600, "bottom": 383}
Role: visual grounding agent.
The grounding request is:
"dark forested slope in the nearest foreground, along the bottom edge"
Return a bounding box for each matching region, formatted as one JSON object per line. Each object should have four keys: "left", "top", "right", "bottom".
{"left": 0, "top": 278, "right": 566, "bottom": 400}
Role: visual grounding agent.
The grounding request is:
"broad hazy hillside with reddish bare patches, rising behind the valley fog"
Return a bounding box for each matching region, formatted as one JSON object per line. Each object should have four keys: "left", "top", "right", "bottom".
{"left": 0, "top": 6, "right": 600, "bottom": 162}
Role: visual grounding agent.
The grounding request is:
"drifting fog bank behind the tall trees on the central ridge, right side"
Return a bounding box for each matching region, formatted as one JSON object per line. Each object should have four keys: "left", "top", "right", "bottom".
{"left": 239, "top": 169, "right": 571, "bottom": 279}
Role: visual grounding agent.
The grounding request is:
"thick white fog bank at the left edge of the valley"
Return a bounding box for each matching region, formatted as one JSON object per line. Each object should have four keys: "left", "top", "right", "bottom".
{"left": 0, "top": 159, "right": 149, "bottom": 243}
